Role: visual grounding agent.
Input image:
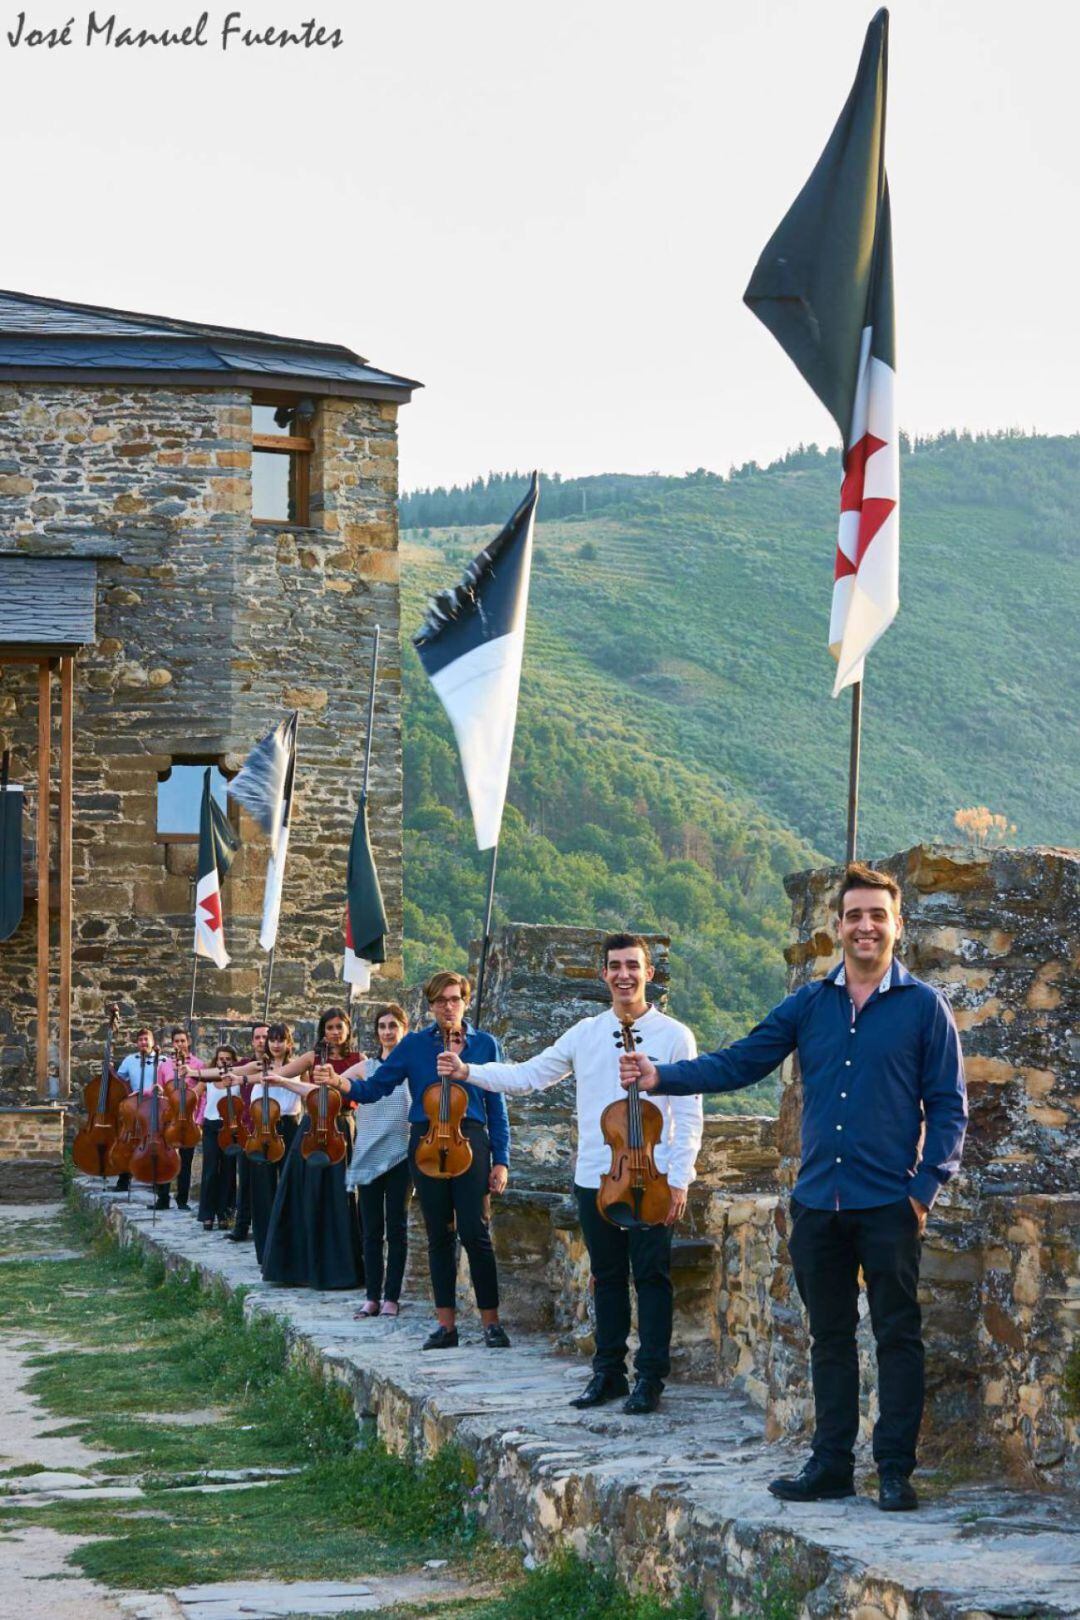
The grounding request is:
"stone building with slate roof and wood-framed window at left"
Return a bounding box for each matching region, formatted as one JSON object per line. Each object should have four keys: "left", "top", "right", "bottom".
{"left": 0, "top": 293, "right": 418, "bottom": 1103}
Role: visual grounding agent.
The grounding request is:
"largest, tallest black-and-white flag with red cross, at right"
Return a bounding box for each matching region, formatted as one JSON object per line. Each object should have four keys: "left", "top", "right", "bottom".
{"left": 745, "top": 10, "right": 900, "bottom": 697}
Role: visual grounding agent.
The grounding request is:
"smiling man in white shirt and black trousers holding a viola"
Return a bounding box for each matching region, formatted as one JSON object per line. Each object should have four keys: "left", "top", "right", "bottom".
{"left": 437, "top": 933, "right": 701, "bottom": 1413}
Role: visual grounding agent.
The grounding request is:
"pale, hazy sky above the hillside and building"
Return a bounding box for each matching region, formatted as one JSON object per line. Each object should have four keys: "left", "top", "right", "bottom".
{"left": 0, "top": 0, "right": 1080, "bottom": 489}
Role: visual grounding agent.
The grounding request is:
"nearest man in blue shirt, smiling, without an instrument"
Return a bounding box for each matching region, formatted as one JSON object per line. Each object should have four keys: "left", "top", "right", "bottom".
{"left": 622, "top": 862, "right": 967, "bottom": 1511}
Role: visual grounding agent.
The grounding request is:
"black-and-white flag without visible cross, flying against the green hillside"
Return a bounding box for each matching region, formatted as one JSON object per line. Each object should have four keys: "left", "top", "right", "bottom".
{"left": 413, "top": 473, "right": 539, "bottom": 849}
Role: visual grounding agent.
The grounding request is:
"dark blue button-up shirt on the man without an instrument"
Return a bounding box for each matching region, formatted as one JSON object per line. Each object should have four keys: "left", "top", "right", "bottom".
{"left": 657, "top": 962, "right": 968, "bottom": 1210}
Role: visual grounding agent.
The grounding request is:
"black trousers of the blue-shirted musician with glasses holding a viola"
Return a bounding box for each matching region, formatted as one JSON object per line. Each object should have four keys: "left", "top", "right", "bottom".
{"left": 408, "top": 1119, "right": 499, "bottom": 1311}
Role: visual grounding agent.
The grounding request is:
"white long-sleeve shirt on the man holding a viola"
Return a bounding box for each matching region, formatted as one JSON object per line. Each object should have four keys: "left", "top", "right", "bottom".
{"left": 468, "top": 1008, "right": 703, "bottom": 1189}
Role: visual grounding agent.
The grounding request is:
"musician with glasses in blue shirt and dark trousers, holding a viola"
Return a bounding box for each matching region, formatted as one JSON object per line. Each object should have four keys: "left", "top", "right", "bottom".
{"left": 330, "top": 972, "right": 510, "bottom": 1349}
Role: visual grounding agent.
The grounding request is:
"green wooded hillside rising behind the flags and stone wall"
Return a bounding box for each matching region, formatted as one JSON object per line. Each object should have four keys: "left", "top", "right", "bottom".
{"left": 403, "top": 436, "right": 1080, "bottom": 1095}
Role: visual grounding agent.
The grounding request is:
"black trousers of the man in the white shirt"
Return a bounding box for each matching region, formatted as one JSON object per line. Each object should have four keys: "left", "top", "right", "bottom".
{"left": 573, "top": 1184, "right": 674, "bottom": 1380}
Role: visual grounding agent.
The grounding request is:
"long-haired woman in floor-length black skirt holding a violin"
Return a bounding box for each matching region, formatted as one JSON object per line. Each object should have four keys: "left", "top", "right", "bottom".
{"left": 262, "top": 1008, "right": 363, "bottom": 1288}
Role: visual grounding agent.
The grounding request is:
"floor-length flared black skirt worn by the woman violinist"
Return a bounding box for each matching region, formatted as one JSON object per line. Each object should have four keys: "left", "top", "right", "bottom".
{"left": 262, "top": 1116, "right": 361, "bottom": 1288}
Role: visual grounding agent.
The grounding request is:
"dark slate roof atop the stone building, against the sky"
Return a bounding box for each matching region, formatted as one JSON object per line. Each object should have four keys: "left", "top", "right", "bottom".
{"left": 0, "top": 292, "right": 423, "bottom": 402}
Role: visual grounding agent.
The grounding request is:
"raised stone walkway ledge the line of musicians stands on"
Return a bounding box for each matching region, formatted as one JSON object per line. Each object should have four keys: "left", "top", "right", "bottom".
{"left": 83, "top": 1186, "right": 1080, "bottom": 1620}
